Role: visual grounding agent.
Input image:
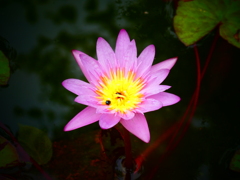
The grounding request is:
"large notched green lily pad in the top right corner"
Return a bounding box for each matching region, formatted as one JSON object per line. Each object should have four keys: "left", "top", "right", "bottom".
{"left": 174, "top": 0, "right": 240, "bottom": 48}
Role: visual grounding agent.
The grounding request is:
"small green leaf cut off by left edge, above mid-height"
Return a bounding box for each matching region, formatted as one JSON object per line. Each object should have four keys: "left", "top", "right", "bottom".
{"left": 0, "top": 51, "right": 10, "bottom": 86}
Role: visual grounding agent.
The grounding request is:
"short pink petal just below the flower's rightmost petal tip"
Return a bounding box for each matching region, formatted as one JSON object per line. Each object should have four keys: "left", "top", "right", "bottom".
{"left": 138, "top": 98, "right": 163, "bottom": 113}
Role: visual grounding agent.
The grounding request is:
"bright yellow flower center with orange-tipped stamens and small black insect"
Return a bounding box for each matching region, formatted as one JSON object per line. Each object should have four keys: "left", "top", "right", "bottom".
{"left": 96, "top": 69, "right": 145, "bottom": 113}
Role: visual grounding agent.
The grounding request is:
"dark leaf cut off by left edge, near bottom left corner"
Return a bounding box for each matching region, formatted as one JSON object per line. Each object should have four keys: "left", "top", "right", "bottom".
{"left": 0, "top": 136, "right": 19, "bottom": 168}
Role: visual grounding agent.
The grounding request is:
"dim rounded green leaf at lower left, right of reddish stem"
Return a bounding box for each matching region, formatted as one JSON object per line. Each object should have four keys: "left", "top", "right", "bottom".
{"left": 18, "top": 125, "right": 52, "bottom": 165}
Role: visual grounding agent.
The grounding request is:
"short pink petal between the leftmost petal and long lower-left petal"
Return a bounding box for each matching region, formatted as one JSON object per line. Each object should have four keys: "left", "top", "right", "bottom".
{"left": 74, "top": 94, "right": 99, "bottom": 108}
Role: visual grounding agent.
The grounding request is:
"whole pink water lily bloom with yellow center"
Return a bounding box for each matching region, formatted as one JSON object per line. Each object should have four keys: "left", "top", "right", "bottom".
{"left": 62, "top": 29, "right": 180, "bottom": 142}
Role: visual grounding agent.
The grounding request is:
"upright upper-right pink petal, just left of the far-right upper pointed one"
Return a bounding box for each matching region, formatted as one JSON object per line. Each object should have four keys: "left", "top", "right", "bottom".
{"left": 137, "top": 45, "right": 155, "bottom": 77}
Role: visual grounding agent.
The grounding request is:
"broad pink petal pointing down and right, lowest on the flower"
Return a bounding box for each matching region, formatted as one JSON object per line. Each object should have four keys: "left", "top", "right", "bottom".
{"left": 120, "top": 113, "right": 150, "bottom": 143}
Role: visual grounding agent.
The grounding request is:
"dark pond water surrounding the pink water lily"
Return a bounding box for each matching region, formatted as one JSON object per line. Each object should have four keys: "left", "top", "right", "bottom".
{"left": 0, "top": 0, "right": 240, "bottom": 180}
